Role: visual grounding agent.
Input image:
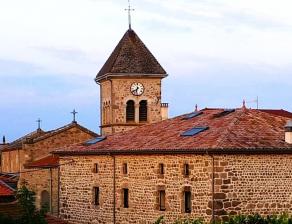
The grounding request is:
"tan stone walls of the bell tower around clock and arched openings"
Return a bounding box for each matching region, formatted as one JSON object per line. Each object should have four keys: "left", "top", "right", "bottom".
{"left": 101, "top": 77, "right": 162, "bottom": 135}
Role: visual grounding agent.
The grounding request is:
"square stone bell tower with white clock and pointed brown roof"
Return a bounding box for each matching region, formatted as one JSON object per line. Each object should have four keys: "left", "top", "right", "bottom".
{"left": 95, "top": 28, "right": 168, "bottom": 135}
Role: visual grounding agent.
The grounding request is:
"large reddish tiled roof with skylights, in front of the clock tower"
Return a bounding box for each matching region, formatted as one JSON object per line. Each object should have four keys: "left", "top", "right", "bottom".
{"left": 55, "top": 108, "right": 292, "bottom": 155}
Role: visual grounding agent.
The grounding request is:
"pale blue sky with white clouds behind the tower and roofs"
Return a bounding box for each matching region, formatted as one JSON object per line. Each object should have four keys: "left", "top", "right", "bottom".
{"left": 0, "top": 0, "right": 292, "bottom": 141}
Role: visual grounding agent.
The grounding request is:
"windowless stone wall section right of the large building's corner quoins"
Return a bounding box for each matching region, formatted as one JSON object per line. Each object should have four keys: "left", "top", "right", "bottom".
{"left": 214, "top": 155, "right": 292, "bottom": 218}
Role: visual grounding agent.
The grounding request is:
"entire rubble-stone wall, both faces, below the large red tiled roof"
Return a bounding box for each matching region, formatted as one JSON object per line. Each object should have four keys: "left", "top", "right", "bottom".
{"left": 60, "top": 155, "right": 292, "bottom": 223}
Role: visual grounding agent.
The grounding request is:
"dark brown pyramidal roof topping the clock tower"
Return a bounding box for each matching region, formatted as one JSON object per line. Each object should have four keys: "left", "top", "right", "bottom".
{"left": 96, "top": 29, "right": 167, "bottom": 82}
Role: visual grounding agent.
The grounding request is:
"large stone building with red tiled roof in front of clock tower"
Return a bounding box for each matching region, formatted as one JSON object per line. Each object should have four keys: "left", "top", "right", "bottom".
{"left": 55, "top": 107, "right": 292, "bottom": 223}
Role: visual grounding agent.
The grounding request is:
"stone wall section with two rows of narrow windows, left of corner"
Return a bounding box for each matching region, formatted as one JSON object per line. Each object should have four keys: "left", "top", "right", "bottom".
{"left": 60, "top": 155, "right": 211, "bottom": 223}
